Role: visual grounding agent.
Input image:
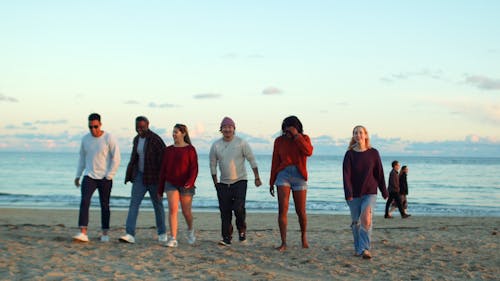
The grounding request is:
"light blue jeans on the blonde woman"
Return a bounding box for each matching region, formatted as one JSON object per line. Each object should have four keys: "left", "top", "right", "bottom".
{"left": 347, "top": 194, "right": 377, "bottom": 255}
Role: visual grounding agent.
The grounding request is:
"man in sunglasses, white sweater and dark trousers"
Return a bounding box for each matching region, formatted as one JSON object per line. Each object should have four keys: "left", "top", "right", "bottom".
{"left": 73, "top": 113, "right": 120, "bottom": 242}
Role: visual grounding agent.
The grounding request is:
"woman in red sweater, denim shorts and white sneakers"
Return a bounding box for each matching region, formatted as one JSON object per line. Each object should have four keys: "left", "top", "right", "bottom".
{"left": 158, "top": 124, "right": 198, "bottom": 247}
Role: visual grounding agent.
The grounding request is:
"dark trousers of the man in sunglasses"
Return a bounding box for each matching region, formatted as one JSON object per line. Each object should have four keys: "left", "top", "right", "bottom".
{"left": 78, "top": 176, "right": 113, "bottom": 230}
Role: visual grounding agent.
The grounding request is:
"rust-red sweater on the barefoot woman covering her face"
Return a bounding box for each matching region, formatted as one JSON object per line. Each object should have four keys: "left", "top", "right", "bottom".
{"left": 269, "top": 134, "right": 313, "bottom": 186}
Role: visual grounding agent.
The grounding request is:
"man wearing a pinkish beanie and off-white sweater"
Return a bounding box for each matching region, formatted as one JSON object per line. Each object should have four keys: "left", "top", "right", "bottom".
{"left": 209, "top": 117, "right": 262, "bottom": 246}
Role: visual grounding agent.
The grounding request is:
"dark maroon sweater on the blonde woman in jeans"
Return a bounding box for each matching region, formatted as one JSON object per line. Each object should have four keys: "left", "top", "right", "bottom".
{"left": 343, "top": 148, "right": 389, "bottom": 199}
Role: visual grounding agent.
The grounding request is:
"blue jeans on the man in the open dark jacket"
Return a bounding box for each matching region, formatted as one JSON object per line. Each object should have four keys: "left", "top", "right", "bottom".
{"left": 125, "top": 172, "right": 166, "bottom": 236}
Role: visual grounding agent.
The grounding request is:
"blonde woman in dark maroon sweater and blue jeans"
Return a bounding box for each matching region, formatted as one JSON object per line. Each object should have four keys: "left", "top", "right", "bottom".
{"left": 343, "top": 126, "right": 389, "bottom": 259}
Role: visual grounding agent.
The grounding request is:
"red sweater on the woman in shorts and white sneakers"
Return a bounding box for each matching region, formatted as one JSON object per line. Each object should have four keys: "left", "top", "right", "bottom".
{"left": 158, "top": 145, "right": 198, "bottom": 195}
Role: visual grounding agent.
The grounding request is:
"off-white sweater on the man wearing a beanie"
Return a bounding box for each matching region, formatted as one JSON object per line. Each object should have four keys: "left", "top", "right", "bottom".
{"left": 209, "top": 136, "right": 257, "bottom": 184}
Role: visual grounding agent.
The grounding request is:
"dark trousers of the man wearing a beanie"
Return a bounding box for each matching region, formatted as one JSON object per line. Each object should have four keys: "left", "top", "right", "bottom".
{"left": 217, "top": 180, "right": 247, "bottom": 241}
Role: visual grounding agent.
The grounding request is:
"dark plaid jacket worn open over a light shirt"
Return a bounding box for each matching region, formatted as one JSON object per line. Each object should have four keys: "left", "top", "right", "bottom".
{"left": 125, "top": 130, "right": 166, "bottom": 185}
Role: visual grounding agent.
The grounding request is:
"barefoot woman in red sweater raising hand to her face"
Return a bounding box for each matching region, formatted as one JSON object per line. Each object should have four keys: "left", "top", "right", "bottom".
{"left": 269, "top": 116, "right": 313, "bottom": 252}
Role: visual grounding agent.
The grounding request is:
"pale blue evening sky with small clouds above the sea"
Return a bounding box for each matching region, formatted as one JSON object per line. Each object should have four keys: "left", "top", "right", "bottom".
{"left": 0, "top": 0, "right": 500, "bottom": 157}
